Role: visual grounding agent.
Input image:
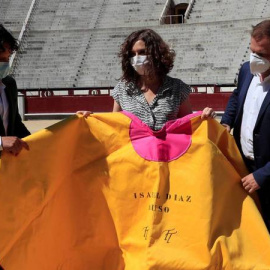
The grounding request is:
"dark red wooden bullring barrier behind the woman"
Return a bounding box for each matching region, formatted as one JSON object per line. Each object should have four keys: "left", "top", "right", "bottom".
{"left": 19, "top": 85, "right": 232, "bottom": 115}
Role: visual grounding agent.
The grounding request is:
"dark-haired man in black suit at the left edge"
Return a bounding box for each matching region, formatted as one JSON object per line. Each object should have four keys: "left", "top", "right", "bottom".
{"left": 0, "top": 24, "right": 30, "bottom": 155}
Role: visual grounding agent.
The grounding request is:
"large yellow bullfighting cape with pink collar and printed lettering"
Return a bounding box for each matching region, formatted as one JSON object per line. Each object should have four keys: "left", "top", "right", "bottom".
{"left": 0, "top": 113, "right": 270, "bottom": 270}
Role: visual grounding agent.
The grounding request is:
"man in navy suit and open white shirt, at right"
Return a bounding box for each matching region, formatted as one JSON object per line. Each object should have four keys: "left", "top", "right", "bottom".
{"left": 221, "top": 20, "right": 270, "bottom": 232}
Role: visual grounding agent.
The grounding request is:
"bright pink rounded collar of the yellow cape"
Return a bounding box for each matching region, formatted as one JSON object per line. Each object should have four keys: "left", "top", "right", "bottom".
{"left": 122, "top": 111, "right": 201, "bottom": 162}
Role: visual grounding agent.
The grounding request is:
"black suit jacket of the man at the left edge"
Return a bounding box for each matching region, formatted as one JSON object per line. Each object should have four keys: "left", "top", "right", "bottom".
{"left": 0, "top": 76, "right": 30, "bottom": 138}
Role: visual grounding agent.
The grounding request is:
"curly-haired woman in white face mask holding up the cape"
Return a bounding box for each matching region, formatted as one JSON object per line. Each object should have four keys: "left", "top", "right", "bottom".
{"left": 79, "top": 29, "right": 215, "bottom": 130}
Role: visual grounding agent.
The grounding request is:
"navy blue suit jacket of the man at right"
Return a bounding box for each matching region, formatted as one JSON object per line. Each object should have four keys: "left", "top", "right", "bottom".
{"left": 221, "top": 62, "right": 270, "bottom": 190}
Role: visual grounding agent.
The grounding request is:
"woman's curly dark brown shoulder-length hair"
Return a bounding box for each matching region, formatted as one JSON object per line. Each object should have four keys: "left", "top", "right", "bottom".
{"left": 119, "top": 29, "right": 175, "bottom": 82}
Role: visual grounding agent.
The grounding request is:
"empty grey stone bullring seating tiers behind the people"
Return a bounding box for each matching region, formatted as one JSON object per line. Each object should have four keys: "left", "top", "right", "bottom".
{"left": 0, "top": 0, "right": 270, "bottom": 88}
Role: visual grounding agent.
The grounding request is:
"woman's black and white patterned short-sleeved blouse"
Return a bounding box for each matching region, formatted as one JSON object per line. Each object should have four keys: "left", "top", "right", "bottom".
{"left": 112, "top": 76, "right": 191, "bottom": 130}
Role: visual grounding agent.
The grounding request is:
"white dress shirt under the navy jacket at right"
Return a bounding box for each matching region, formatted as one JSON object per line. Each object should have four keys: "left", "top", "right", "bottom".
{"left": 240, "top": 76, "right": 270, "bottom": 160}
